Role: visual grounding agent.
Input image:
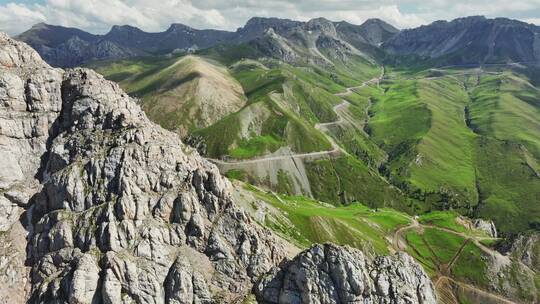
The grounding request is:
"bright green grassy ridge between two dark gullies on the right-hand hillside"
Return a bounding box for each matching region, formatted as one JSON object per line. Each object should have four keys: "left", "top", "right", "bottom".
{"left": 409, "top": 77, "right": 477, "bottom": 211}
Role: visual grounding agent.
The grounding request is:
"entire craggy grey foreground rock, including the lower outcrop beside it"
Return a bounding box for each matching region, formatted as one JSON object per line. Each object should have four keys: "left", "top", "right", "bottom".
{"left": 0, "top": 34, "right": 435, "bottom": 303}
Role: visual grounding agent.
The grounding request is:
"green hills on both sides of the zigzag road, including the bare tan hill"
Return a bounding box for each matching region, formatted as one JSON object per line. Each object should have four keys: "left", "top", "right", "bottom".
{"left": 89, "top": 50, "right": 540, "bottom": 233}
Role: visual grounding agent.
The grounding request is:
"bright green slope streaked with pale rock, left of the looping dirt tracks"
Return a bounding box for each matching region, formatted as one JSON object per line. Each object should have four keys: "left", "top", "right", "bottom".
{"left": 243, "top": 186, "right": 410, "bottom": 254}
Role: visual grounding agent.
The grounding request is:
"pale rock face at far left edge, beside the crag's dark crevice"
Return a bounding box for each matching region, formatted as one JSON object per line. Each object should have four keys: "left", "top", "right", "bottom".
{"left": 0, "top": 33, "right": 62, "bottom": 303}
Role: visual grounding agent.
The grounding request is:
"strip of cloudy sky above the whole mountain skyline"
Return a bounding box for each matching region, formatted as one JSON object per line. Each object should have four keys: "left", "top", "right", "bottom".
{"left": 0, "top": 0, "right": 540, "bottom": 35}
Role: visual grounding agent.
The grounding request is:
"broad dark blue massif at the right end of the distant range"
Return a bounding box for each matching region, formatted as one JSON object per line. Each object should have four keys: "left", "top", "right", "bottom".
{"left": 383, "top": 16, "right": 540, "bottom": 65}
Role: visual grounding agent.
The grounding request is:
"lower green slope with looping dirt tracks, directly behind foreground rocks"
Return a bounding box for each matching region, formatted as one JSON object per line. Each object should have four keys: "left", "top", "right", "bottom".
{"left": 239, "top": 185, "right": 540, "bottom": 303}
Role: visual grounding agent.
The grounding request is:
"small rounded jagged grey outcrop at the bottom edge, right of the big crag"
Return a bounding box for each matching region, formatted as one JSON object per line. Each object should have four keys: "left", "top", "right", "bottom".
{"left": 254, "top": 244, "right": 436, "bottom": 304}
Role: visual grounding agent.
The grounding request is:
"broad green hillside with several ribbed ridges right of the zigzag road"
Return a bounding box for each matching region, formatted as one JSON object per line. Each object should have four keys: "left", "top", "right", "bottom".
{"left": 362, "top": 71, "right": 540, "bottom": 232}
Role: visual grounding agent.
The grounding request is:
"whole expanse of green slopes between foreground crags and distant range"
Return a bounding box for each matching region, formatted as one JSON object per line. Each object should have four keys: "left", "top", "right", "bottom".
{"left": 88, "top": 32, "right": 540, "bottom": 303}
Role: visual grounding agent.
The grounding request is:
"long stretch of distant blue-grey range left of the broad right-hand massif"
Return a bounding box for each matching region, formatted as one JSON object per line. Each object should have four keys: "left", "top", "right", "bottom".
{"left": 16, "top": 18, "right": 397, "bottom": 67}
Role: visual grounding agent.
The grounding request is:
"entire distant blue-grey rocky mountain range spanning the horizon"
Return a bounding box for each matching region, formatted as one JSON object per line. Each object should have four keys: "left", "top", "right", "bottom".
{"left": 16, "top": 16, "right": 540, "bottom": 67}
